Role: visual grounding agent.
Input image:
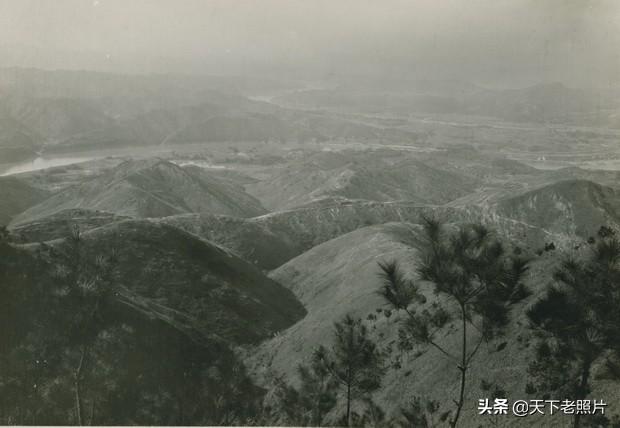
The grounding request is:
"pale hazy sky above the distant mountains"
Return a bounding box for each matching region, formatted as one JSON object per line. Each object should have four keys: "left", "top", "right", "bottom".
{"left": 0, "top": 0, "right": 620, "bottom": 87}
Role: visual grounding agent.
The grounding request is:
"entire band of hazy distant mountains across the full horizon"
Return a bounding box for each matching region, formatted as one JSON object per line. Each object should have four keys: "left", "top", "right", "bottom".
{"left": 0, "top": 68, "right": 620, "bottom": 166}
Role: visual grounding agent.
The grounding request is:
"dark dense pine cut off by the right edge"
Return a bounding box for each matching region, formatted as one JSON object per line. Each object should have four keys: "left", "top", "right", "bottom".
{"left": 527, "top": 234, "right": 620, "bottom": 428}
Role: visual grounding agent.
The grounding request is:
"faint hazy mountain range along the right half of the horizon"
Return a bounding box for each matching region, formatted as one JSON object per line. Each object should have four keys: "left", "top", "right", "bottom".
{"left": 276, "top": 82, "right": 620, "bottom": 128}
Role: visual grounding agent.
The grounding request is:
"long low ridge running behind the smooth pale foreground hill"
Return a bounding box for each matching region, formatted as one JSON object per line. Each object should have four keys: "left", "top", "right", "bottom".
{"left": 158, "top": 199, "right": 560, "bottom": 270}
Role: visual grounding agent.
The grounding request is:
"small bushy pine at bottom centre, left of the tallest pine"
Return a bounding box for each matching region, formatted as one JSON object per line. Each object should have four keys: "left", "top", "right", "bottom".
{"left": 313, "top": 315, "right": 384, "bottom": 426}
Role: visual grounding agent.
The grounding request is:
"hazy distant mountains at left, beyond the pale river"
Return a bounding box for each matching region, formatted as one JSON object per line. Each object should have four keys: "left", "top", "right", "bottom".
{"left": 0, "top": 69, "right": 422, "bottom": 161}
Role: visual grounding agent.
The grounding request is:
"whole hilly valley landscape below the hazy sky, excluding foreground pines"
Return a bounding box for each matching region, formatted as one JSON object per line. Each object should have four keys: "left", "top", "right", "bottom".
{"left": 0, "top": 70, "right": 620, "bottom": 428}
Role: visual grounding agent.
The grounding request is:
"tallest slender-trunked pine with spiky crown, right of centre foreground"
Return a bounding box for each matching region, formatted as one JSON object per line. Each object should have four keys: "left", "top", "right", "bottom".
{"left": 379, "top": 218, "right": 527, "bottom": 427}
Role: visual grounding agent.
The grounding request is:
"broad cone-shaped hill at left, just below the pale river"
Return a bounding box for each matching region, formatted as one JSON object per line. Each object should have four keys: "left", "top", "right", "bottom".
{"left": 9, "top": 159, "right": 265, "bottom": 223}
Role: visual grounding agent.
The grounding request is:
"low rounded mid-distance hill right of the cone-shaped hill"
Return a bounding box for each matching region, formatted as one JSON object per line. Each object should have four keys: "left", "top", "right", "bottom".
{"left": 246, "top": 152, "right": 477, "bottom": 210}
